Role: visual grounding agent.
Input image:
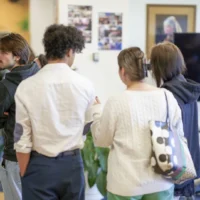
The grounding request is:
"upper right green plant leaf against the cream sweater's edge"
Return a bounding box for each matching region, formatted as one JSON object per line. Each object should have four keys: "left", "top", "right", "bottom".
{"left": 95, "top": 147, "right": 109, "bottom": 172}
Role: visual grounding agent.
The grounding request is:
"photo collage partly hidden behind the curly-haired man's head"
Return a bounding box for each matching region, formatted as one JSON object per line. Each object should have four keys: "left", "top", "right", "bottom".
{"left": 68, "top": 5, "right": 92, "bottom": 43}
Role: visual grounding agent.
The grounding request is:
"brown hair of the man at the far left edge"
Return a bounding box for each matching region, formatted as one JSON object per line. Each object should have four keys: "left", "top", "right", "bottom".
{"left": 0, "top": 33, "right": 30, "bottom": 65}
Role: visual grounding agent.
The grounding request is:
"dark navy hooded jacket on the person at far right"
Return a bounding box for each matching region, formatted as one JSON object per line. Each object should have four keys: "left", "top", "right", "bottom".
{"left": 162, "top": 75, "right": 200, "bottom": 177}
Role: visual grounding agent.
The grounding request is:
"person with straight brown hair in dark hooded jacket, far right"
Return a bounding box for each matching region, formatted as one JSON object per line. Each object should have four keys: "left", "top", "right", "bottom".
{"left": 151, "top": 42, "right": 200, "bottom": 200}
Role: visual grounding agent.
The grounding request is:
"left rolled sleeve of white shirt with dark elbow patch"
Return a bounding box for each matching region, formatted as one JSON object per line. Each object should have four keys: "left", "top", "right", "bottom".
{"left": 14, "top": 88, "right": 32, "bottom": 153}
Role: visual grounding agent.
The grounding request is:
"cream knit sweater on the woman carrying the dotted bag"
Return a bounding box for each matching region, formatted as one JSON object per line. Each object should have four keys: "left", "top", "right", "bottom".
{"left": 91, "top": 89, "right": 183, "bottom": 196}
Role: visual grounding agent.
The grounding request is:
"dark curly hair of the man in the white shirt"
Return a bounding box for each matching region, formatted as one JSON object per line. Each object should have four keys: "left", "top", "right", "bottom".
{"left": 43, "top": 24, "right": 85, "bottom": 60}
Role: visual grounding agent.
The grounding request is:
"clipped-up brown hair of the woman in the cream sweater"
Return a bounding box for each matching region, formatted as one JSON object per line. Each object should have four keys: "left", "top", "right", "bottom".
{"left": 118, "top": 47, "right": 145, "bottom": 81}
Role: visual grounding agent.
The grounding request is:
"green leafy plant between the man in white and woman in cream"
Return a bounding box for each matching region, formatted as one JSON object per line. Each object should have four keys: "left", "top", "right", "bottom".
{"left": 82, "top": 132, "right": 109, "bottom": 197}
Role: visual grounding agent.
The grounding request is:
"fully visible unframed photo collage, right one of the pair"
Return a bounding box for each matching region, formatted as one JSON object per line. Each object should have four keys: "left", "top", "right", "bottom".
{"left": 98, "top": 13, "right": 122, "bottom": 50}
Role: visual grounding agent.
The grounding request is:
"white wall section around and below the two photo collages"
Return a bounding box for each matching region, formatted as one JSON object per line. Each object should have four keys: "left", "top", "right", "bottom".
{"left": 59, "top": 0, "right": 130, "bottom": 102}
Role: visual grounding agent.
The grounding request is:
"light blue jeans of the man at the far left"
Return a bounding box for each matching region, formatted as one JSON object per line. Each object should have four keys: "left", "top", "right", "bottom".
{"left": 0, "top": 160, "right": 22, "bottom": 200}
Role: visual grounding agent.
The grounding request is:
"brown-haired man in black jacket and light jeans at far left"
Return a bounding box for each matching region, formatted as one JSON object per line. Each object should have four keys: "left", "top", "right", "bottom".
{"left": 0, "top": 33, "right": 39, "bottom": 200}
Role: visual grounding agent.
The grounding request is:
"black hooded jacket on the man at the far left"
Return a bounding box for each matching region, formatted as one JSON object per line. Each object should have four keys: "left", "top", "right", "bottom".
{"left": 0, "top": 63, "right": 39, "bottom": 161}
